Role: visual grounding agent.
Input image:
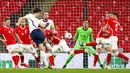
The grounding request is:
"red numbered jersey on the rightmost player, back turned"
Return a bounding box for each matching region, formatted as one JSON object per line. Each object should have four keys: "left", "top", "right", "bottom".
{"left": 107, "top": 18, "right": 121, "bottom": 36}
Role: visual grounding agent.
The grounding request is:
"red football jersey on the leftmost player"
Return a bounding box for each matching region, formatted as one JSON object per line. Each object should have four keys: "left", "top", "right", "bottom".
{"left": 0, "top": 26, "right": 16, "bottom": 45}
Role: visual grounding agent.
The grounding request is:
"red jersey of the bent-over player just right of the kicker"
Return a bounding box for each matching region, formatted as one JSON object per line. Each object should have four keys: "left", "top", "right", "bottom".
{"left": 45, "top": 30, "right": 62, "bottom": 44}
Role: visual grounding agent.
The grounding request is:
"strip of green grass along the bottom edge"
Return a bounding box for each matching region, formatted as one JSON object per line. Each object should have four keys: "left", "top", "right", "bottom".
{"left": 0, "top": 68, "right": 130, "bottom": 73}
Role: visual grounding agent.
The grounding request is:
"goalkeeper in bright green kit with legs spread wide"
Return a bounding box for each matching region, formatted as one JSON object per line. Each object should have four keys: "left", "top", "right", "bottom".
{"left": 63, "top": 20, "right": 103, "bottom": 68}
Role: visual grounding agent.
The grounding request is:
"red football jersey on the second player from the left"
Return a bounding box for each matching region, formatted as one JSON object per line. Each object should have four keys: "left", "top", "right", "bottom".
{"left": 15, "top": 26, "right": 31, "bottom": 44}
